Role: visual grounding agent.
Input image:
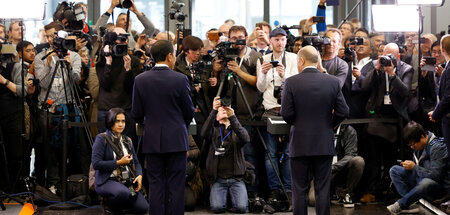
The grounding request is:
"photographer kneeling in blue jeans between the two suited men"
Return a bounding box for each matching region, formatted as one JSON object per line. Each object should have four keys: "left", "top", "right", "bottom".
{"left": 202, "top": 97, "right": 250, "bottom": 213}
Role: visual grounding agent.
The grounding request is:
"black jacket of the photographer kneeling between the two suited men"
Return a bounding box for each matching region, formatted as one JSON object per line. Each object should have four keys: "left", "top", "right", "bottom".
{"left": 202, "top": 110, "right": 250, "bottom": 181}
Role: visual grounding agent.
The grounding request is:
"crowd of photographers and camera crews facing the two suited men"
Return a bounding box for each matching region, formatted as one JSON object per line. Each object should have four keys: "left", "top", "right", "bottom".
{"left": 0, "top": 0, "right": 450, "bottom": 213}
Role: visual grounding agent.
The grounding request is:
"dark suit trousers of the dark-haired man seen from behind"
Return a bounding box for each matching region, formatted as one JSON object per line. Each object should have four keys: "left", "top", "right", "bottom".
{"left": 145, "top": 151, "right": 187, "bottom": 215}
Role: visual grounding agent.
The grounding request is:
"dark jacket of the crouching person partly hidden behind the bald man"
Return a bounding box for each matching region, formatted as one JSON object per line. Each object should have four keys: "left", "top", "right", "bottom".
{"left": 331, "top": 125, "right": 358, "bottom": 173}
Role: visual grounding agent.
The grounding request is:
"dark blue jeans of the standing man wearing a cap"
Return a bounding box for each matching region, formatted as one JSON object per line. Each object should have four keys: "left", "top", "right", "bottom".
{"left": 263, "top": 131, "right": 291, "bottom": 192}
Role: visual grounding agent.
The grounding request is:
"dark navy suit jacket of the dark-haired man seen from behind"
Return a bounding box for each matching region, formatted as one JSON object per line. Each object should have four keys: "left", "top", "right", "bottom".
{"left": 131, "top": 67, "right": 194, "bottom": 153}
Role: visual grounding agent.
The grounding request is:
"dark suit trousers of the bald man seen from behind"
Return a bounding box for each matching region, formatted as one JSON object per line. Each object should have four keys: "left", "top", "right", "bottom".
{"left": 290, "top": 155, "right": 333, "bottom": 215}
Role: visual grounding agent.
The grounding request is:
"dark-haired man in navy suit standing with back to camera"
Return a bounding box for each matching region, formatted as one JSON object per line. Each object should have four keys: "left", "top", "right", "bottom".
{"left": 132, "top": 40, "right": 194, "bottom": 215}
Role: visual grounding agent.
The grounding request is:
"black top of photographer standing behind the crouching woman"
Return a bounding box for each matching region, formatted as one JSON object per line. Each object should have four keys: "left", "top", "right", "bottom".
{"left": 95, "top": 56, "right": 140, "bottom": 110}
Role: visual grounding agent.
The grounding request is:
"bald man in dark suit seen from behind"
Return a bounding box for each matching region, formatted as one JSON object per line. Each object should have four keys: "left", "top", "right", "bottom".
{"left": 281, "top": 46, "right": 348, "bottom": 214}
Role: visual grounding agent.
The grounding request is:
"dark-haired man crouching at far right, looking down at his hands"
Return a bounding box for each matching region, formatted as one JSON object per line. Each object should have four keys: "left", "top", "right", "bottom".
{"left": 387, "top": 121, "right": 447, "bottom": 214}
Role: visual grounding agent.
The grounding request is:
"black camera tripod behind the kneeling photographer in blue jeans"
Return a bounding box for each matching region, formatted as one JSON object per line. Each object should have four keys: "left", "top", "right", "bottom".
{"left": 216, "top": 68, "right": 289, "bottom": 203}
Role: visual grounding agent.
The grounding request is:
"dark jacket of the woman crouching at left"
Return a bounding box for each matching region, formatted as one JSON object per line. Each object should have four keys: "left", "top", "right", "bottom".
{"left": 91, "top": 130, "right": 142, "bottom": 186}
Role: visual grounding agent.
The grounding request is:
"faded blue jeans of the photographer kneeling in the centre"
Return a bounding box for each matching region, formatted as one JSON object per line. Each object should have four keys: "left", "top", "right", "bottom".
{"left": 209, "top": 178, "right": 248, "bottom": 213}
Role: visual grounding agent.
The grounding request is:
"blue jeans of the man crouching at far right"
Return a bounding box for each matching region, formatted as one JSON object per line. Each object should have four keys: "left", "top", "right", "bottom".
{"left": 389, "top": 165, "right": 445, "bottom": 209}
